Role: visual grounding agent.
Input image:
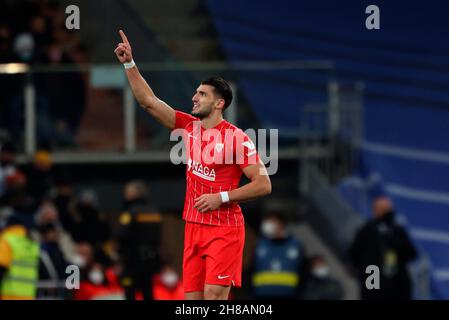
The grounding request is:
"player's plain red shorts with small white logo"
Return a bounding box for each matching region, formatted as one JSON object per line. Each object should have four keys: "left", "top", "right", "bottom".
{"left": 183, "top": 222, "right": 245, "bottom": 292}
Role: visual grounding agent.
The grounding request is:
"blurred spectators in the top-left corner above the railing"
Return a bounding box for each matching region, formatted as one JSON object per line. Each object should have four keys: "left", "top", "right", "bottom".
{"left": 0, "top": 0, "right": 87, "bottom": 64}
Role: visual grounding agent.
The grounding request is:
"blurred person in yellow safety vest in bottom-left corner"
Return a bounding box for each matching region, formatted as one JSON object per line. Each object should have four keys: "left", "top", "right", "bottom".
{"left": 0, "top": 215, "right": 40, "bottom": 300}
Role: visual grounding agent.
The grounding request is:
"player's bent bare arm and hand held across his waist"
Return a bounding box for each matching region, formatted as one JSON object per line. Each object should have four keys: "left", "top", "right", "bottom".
{"left": 194, "top": 160, "right": 271, "bottom": 212}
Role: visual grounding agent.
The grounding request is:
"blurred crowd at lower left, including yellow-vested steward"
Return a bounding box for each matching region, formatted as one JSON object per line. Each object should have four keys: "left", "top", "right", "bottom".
{"left": 0, "top": 142, "right": 184, "bottom": 300}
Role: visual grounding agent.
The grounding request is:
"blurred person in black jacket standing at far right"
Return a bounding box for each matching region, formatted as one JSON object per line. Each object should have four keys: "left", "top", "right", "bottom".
{"left": 350, "top": 196, "right": 418, "bottom": 300}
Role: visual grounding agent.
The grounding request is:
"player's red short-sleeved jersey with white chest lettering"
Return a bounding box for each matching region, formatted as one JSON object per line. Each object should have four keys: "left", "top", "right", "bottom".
{"left": 175, "top": 111, "right": 259, "bottom": 227}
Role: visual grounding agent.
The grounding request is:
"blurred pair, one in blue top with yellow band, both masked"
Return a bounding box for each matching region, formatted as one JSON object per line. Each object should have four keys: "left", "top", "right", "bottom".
{"left": 250, "top": 210, "right": 344, "bottom": 300}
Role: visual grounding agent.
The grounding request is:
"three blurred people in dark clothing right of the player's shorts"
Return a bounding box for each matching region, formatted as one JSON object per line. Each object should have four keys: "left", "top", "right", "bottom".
{"left": 251, "top": 194, "right": 419, "bottom": 300}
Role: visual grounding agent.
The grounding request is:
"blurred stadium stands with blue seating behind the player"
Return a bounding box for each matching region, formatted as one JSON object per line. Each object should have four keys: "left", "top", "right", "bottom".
{"left": 0, "top": 0, "right": 449, "bottom": 299}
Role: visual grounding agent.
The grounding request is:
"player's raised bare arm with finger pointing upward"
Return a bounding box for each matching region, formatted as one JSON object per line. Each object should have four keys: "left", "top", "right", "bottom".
{"left": 114, "top": 30, "right": 176, "bottom": 130}
